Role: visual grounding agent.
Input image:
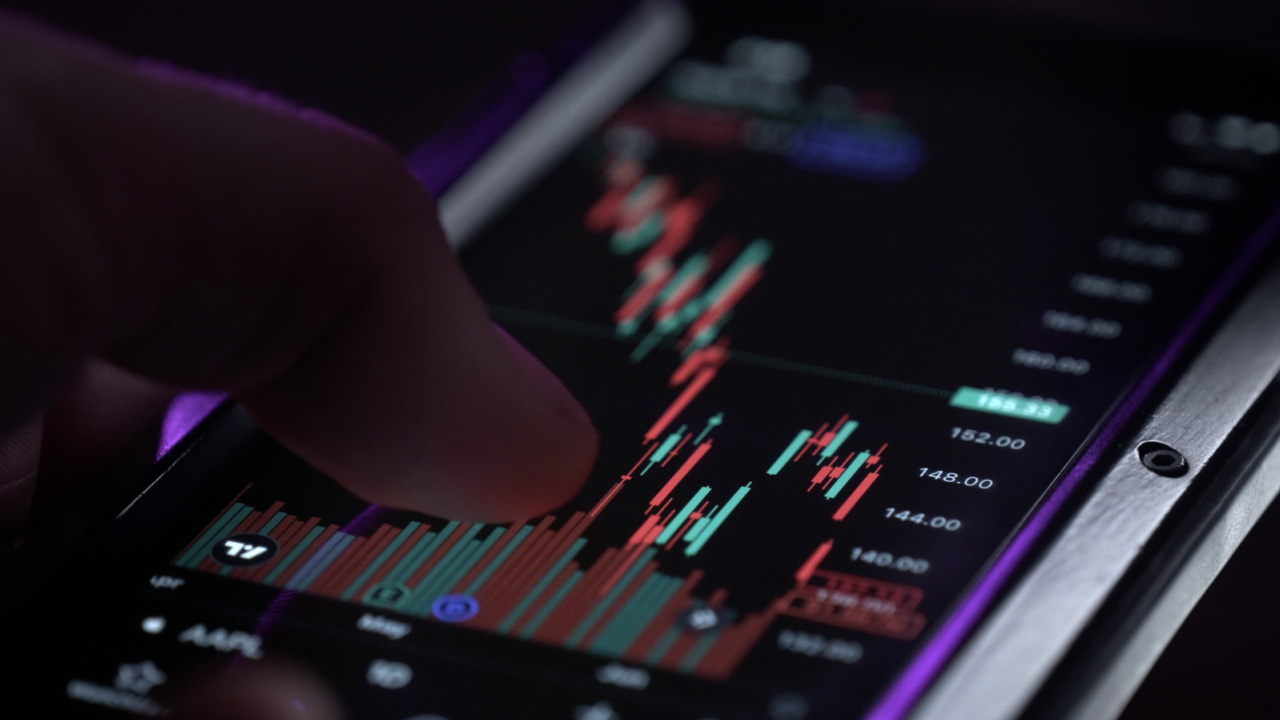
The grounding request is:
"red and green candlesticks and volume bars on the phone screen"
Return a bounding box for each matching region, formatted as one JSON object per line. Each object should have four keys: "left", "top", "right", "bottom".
{"left": 172, "top": 148, "right": 924, "bottom": 679}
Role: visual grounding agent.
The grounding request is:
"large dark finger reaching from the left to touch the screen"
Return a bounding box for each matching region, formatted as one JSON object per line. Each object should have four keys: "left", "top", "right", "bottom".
{"left": 0, "top": 14, "right": 595, "bottom": 520}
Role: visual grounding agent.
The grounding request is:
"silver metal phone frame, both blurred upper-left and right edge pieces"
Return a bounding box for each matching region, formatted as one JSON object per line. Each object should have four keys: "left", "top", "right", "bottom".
{"left": 427, "top": 1, "right": 1280, "bottom": 720}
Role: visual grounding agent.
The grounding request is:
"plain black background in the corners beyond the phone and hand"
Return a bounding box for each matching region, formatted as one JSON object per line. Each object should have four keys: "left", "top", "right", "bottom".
{"left": 8, "top": 0, "right": 1280, "bottom": 720}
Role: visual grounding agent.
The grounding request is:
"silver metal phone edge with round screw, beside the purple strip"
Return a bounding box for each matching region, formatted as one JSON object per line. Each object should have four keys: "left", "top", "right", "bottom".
{"left": 906, "top": 242, "right": 1280, "bottom": 720}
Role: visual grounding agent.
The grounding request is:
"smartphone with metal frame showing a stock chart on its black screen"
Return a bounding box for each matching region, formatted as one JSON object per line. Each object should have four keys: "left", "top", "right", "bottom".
{"left": 14, "top": 1, "right": 1280, "bottom": 720}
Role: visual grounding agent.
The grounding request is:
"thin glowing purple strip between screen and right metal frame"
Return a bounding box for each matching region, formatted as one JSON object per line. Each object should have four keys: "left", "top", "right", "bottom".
{"left": 864, "top": 198, "right": 1280, "bottom": 720}
